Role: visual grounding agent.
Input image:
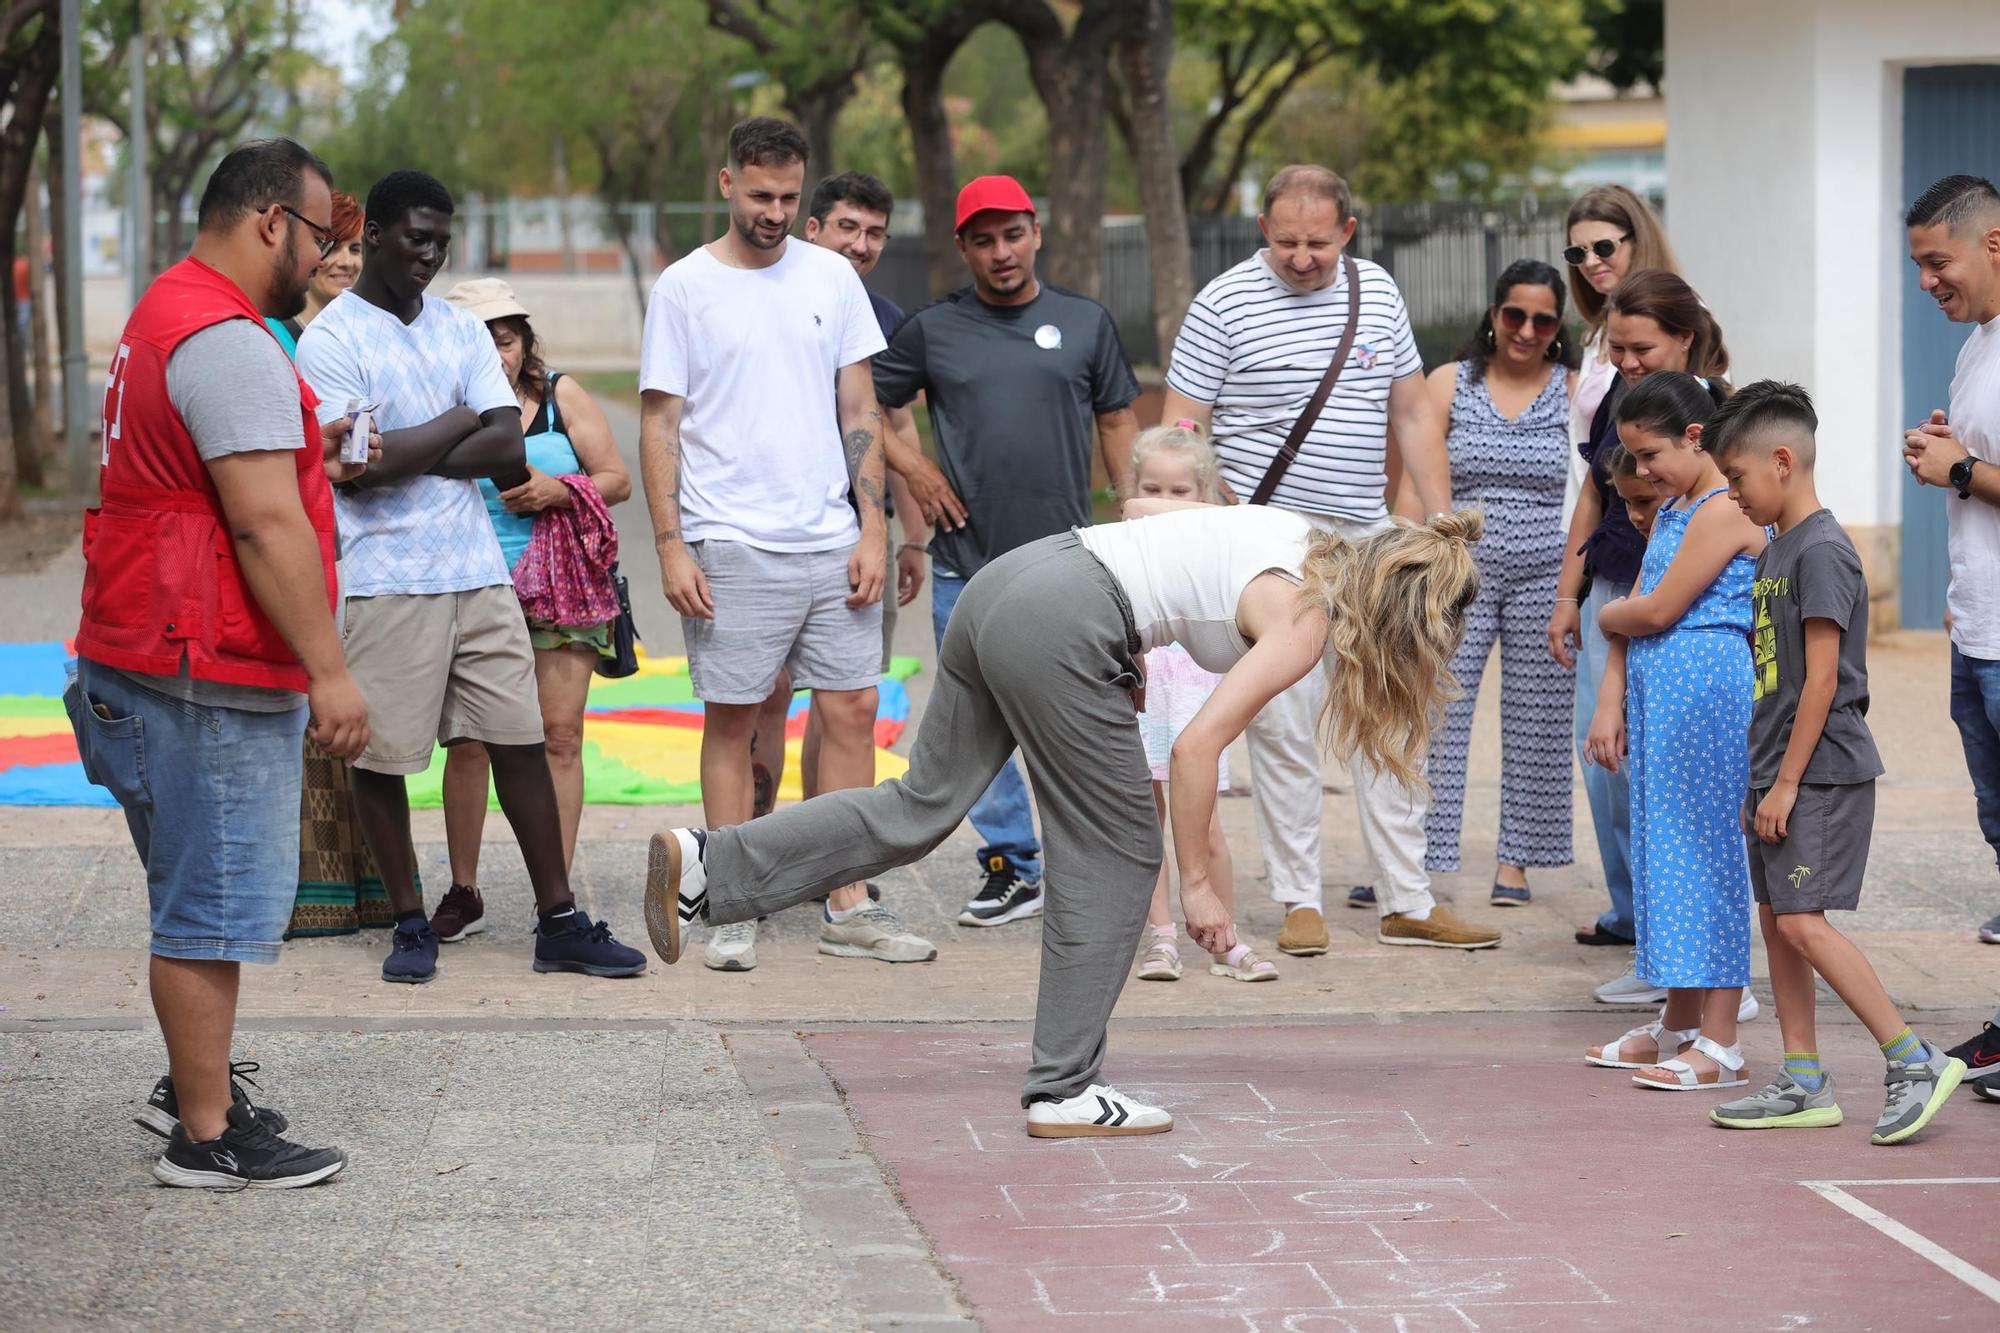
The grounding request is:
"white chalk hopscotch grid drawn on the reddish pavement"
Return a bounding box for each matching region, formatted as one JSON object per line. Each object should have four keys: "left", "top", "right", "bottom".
{"left": 992, "top": 1083, "right": 1612, "bottom": 1333}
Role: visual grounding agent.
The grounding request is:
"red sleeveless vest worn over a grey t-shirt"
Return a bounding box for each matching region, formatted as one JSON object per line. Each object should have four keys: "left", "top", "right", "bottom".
{"left": 76, "top": 258, "right": 336, "bottom": 691}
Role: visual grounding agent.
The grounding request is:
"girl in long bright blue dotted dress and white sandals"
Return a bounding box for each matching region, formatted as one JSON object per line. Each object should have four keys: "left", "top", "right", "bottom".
{"left": 1586, "top": 372, "right": 1764, "bottom": 1091}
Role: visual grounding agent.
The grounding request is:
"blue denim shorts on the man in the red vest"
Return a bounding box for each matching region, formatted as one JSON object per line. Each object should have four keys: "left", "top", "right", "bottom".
{"left": 62, "top": 660, "right": 306, "bottom": 963}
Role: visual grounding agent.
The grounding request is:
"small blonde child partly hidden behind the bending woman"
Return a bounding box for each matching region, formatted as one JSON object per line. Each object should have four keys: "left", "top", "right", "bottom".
{"left": 1128, "top": 420, "right": 1278, "bottom": 981}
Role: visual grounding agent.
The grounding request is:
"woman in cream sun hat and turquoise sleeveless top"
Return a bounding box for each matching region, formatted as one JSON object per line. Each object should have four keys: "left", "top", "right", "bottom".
{"left": 430, "top": 278, "right": 632, "bottom": 941}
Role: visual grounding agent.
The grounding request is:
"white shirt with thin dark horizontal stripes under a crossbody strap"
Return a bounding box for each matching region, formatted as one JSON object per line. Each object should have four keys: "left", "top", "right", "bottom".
{"left": 1166, "top": 250, "right": 1424, "bottom": 520}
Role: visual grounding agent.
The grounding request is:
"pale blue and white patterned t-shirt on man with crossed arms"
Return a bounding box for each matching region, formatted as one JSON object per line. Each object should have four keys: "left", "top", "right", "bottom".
{"left": 298, "top": 290, "right": 518, "bottom": 596}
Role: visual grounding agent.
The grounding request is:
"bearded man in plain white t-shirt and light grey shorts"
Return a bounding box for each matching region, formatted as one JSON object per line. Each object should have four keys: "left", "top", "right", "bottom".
{"left": 638, "top": 116, "right": 916, "bottom": 971}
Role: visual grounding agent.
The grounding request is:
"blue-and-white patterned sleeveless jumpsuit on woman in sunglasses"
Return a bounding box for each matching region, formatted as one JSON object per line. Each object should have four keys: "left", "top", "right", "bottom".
{"left": 1424, "top": 362, "right": 1574, "bottom": 871}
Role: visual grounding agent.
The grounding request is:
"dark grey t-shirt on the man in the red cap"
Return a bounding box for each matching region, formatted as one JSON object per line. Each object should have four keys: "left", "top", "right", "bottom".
{"left": 874, "top": 282, "right": 1138, "bottom": 578}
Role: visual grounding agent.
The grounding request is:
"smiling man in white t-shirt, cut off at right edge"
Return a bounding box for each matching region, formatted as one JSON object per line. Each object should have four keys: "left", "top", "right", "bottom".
{"left": 1902, "top": 176, "right": 2000, "bottom": 944}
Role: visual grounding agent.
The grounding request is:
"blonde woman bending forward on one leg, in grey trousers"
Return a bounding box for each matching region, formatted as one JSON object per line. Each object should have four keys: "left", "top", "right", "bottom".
{"left": 646, "top": 498, "right": 1482, "bottom": 1137}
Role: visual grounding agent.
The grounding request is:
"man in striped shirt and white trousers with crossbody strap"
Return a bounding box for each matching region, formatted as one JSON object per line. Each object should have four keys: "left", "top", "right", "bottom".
{"left": 1160, "top": 166, "right": 1500, "bottom": 955}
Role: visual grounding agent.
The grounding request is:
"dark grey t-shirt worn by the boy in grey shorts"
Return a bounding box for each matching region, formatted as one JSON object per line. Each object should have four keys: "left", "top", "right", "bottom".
{"left": 1750, "top": 508, "right": 1882, "bottom": 791}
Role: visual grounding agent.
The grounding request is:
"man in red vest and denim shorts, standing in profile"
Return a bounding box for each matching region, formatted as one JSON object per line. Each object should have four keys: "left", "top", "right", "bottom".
{"left": 64, "top": 138, "right": 368, "bottom": 1189}
